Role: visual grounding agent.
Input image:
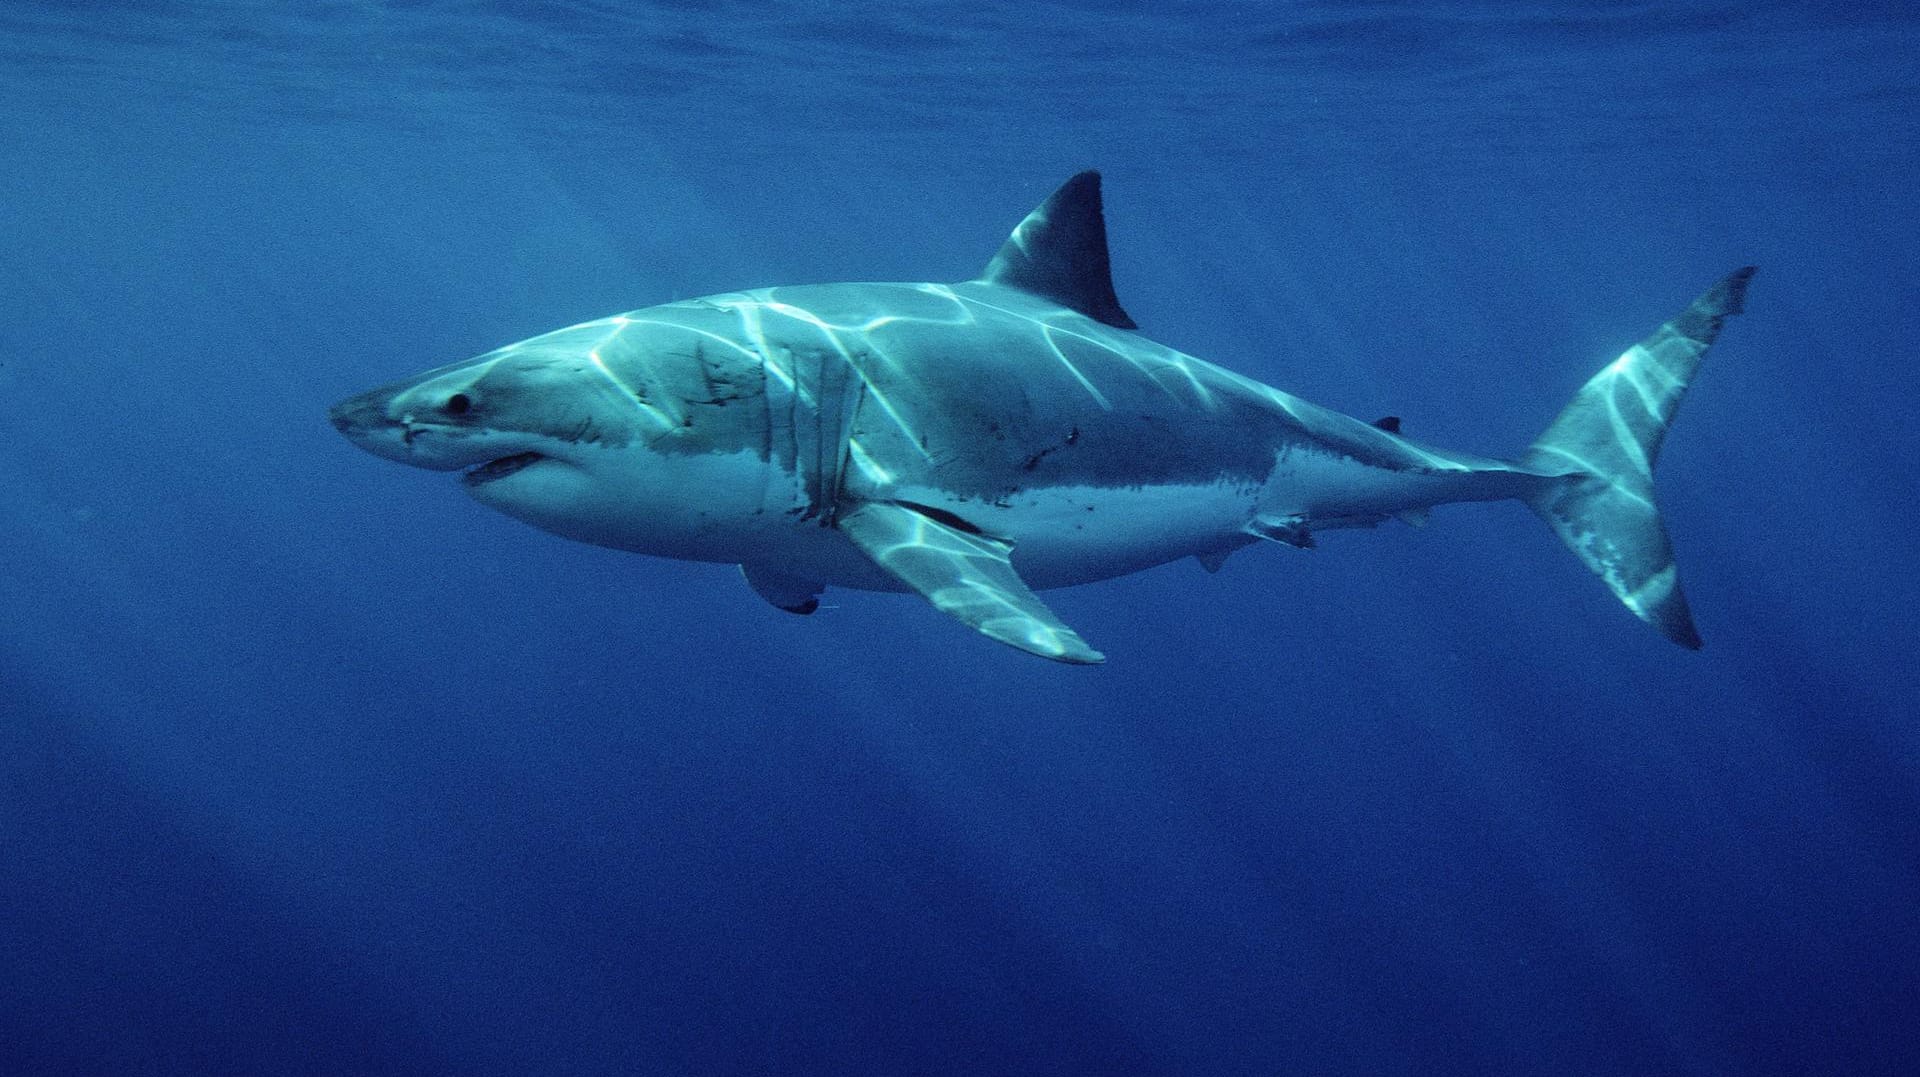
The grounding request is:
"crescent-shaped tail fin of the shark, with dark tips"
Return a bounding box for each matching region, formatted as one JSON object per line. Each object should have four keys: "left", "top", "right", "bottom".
{"left": 1523, "top": 265, "right": 1753, "bottom": 649}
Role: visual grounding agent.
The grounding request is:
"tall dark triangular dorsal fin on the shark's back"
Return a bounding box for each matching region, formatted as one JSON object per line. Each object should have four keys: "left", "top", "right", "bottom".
{"left": 979, "top": 171, "right": 1139, "bottom": 328}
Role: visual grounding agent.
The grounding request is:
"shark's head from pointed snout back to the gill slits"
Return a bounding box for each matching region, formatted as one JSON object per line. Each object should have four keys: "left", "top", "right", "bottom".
{"left": 330, "top": 315, "right": 783, "bottom": 557}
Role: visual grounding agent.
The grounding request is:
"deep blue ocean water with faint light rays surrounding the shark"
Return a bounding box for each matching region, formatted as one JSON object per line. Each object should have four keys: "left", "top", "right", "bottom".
{"left": 0, "top": 0, "right": 1920, "bottom": 1075}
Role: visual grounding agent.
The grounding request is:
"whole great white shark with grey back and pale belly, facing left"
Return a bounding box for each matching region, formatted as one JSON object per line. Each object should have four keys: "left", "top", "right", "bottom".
{"left": 332, "top": 173, "right": 1753, "bottom": 662}
